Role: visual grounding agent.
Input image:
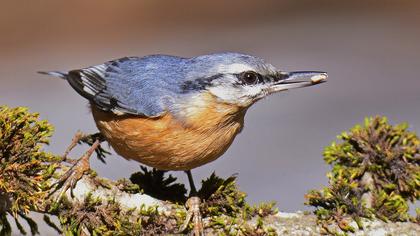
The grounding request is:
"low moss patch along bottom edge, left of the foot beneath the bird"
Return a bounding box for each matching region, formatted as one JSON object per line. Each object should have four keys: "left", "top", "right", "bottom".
{"left": 57, "top": 195, "right": 176, "bottom": 235}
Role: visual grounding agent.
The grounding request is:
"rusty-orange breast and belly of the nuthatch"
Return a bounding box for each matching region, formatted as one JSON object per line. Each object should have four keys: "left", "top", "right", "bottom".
{"left": 92, "top": 95, "right": 245, "bottom": 170}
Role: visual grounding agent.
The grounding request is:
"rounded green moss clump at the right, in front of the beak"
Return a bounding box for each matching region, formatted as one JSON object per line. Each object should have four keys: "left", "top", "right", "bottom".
{"left": 306, "top": 117, "right": 420, "bottom": 231}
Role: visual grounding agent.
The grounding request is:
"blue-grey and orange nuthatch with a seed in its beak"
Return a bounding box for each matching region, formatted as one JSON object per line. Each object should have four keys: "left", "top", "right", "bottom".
{"left": 41, "top": 52, "right": 328, "bottom": 234}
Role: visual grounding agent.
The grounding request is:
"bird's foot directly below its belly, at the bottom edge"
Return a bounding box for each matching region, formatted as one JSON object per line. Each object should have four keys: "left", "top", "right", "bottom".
{"left": 179, "top": 196, "right": 204, "bottom": 236}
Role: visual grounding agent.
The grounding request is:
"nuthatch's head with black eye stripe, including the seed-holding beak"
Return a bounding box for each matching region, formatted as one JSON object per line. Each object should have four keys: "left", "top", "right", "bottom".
{"left": 184, "top": 53, "right": 327, "bottom": 107}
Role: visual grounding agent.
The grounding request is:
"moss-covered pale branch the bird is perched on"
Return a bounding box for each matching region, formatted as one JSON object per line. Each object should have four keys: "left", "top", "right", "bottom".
{"left": 0, "top": 106, "right": 420, "bottom": 235}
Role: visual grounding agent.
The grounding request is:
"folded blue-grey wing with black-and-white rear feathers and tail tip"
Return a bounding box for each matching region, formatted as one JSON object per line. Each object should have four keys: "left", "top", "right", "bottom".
{"left": 43, "top": 57, "right": 181, "bottom": 117}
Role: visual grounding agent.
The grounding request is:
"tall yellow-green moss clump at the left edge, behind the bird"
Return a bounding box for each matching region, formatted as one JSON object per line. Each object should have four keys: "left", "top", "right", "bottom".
{"left": 0, "top": 106, "right": 60, "bottom": 235}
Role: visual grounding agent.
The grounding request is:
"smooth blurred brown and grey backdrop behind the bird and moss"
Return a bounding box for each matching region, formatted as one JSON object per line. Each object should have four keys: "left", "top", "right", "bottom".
{"left": 0, "top": 0, "right": 420, "bottom": 235}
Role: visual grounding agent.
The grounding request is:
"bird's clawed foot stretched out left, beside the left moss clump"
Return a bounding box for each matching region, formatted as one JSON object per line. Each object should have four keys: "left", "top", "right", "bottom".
{"left": 49, "top": 139, "right": 100, "bottom": 202}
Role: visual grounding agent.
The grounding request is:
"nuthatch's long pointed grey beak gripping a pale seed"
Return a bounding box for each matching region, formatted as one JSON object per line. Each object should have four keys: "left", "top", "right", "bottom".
{"left": 270, "top": 71, "right": 328, "bottom": 92}
